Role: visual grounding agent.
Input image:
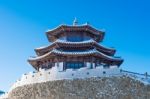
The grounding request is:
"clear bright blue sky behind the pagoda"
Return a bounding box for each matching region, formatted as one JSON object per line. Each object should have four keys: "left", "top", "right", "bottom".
{"left": 0, "top": 0, "right": 150, "bottom": 91}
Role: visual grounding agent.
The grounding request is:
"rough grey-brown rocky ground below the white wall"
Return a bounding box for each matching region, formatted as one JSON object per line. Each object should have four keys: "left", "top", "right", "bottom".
{"left": 9, "top": 76, "right": 150, "bottom": 99}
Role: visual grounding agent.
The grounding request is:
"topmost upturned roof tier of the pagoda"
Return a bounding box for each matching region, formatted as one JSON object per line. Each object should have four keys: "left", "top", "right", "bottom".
{"left": 46, "top": 25, "right": 105, "bottom": 42}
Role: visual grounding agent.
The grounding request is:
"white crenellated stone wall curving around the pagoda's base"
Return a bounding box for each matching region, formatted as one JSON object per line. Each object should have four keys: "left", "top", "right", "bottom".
{"left": 10, "top": 66, "right": 120, "bottom": 91}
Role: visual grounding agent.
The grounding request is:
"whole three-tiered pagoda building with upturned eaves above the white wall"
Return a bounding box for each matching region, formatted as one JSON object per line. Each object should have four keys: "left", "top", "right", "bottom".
{"left": 28, "top": 21, "right": 123, "bottom": 71}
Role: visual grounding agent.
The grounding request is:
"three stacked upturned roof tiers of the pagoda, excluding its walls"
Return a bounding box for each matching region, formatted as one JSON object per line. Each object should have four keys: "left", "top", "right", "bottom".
{"left": 28, "top": 25, "right": 123, "bottom": 68}
